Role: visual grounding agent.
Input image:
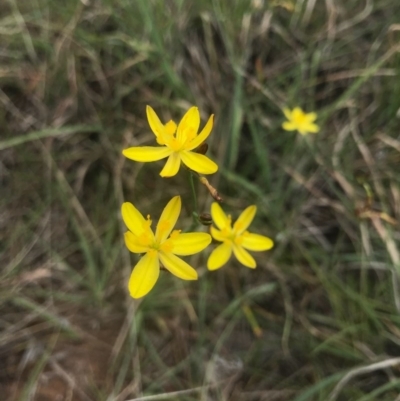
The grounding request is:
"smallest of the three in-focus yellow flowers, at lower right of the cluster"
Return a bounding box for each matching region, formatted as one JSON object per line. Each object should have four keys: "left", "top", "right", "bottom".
{"left": 207, "top": 202, "right": 274, "bottom": 270}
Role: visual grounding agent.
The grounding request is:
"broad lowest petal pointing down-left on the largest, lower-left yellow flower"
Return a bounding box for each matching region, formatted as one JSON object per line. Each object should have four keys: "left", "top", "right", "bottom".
{"left": 128, "top": 252, "right": 160, "bottom": 298}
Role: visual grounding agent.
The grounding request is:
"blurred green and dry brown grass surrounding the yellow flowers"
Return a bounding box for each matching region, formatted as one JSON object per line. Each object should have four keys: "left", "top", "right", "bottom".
{"left": 0, "top": 0, "right": 400, "bottom": 401}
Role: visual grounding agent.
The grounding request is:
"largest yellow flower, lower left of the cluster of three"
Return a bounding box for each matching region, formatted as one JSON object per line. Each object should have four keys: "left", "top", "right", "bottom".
{"left": 122, "top": 196, "right": 211, "bottom": 298}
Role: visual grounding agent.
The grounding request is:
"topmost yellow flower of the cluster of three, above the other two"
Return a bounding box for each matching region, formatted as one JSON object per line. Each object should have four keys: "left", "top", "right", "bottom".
{"left": 122, "top": 106, "right": 218, "bottom": 177}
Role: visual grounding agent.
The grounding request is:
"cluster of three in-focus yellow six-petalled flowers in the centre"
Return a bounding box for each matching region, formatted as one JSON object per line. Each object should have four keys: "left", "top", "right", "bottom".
{"left": 121, "top": 106, "right": 278, "bottom": 298}
